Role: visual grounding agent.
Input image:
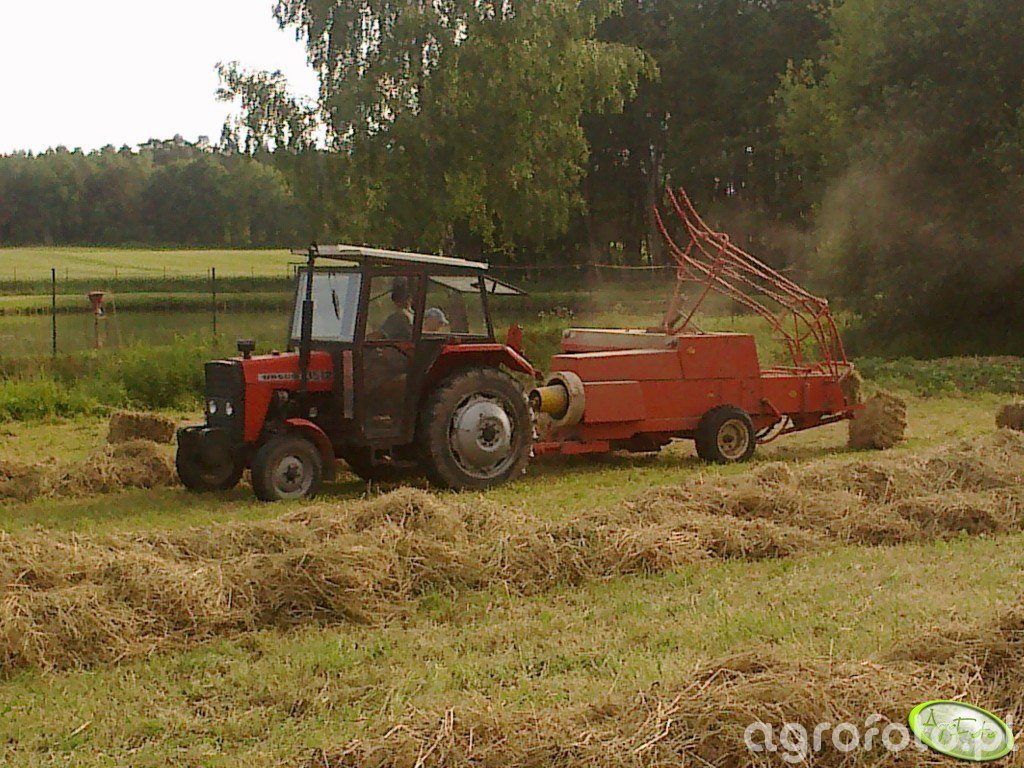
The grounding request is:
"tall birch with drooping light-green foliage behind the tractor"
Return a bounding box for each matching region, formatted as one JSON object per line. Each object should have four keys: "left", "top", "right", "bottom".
{"left": 224, "top": 0, "right": 648, "bottom": 255}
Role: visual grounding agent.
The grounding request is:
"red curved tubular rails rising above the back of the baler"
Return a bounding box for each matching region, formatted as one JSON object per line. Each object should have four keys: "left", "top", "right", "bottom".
{"left": 654, "top": 189, "right": 849, "bottom": 377}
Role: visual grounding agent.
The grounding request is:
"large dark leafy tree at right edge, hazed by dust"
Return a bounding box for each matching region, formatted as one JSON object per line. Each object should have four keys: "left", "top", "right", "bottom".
{"left": 780, "top": 0, "right": 1024, "bottom": 354}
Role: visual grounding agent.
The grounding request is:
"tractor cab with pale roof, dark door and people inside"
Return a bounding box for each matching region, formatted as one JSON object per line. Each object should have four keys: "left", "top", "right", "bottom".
{"left": 290, "top": 246, "right": 523, "bottom": 453}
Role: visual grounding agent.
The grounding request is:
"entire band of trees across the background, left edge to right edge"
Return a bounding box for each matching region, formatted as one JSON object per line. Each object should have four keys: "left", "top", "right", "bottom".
{"left": 0, "top": 0, "right": 1024, "bottom": 354}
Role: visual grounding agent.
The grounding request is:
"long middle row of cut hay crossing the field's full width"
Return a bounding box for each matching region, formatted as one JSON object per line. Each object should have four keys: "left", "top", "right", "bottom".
{"left": 0, "top": 430, "right": 1024, "bottom": 670}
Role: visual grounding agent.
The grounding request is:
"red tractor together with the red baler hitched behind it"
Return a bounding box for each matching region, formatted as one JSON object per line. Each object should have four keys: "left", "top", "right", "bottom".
{"left": 177, "top": 191, "right": 860, "bottom": 501}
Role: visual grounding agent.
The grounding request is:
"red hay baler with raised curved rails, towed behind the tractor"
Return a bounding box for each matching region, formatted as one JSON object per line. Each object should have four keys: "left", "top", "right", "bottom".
{"left": 530, "top": 188, "right": 859, "bottom": 462}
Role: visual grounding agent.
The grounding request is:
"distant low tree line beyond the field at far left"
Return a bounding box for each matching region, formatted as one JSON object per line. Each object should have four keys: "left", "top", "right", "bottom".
{"left": 0, "top": 137, "right": 308, "bottom": 248}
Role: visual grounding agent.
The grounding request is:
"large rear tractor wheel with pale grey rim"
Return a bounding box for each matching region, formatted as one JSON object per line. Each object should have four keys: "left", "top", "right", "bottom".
{"left": 417, "top": 368, "right": 532, "bottom": 490}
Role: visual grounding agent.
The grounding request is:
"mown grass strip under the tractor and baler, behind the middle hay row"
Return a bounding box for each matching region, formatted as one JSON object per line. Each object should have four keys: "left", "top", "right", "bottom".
{"left": 0, "top": 394, "right": 1004, "bottom": 532}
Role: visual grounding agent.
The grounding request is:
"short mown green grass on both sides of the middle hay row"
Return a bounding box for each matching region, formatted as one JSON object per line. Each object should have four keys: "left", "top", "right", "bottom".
{"left": 0, "top": 393, "right": 1024, "bottom": 766}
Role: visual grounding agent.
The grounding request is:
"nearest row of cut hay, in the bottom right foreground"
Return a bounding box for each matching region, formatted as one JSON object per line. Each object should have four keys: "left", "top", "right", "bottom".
{"left": 307, "top": 604, "right": 1024, "bottom": 768}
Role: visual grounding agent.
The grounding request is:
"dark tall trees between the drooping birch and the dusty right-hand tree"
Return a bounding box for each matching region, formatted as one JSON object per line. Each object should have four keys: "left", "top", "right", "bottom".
{"left": 587, "top": 0, "right": 827, "bottom": 262}
